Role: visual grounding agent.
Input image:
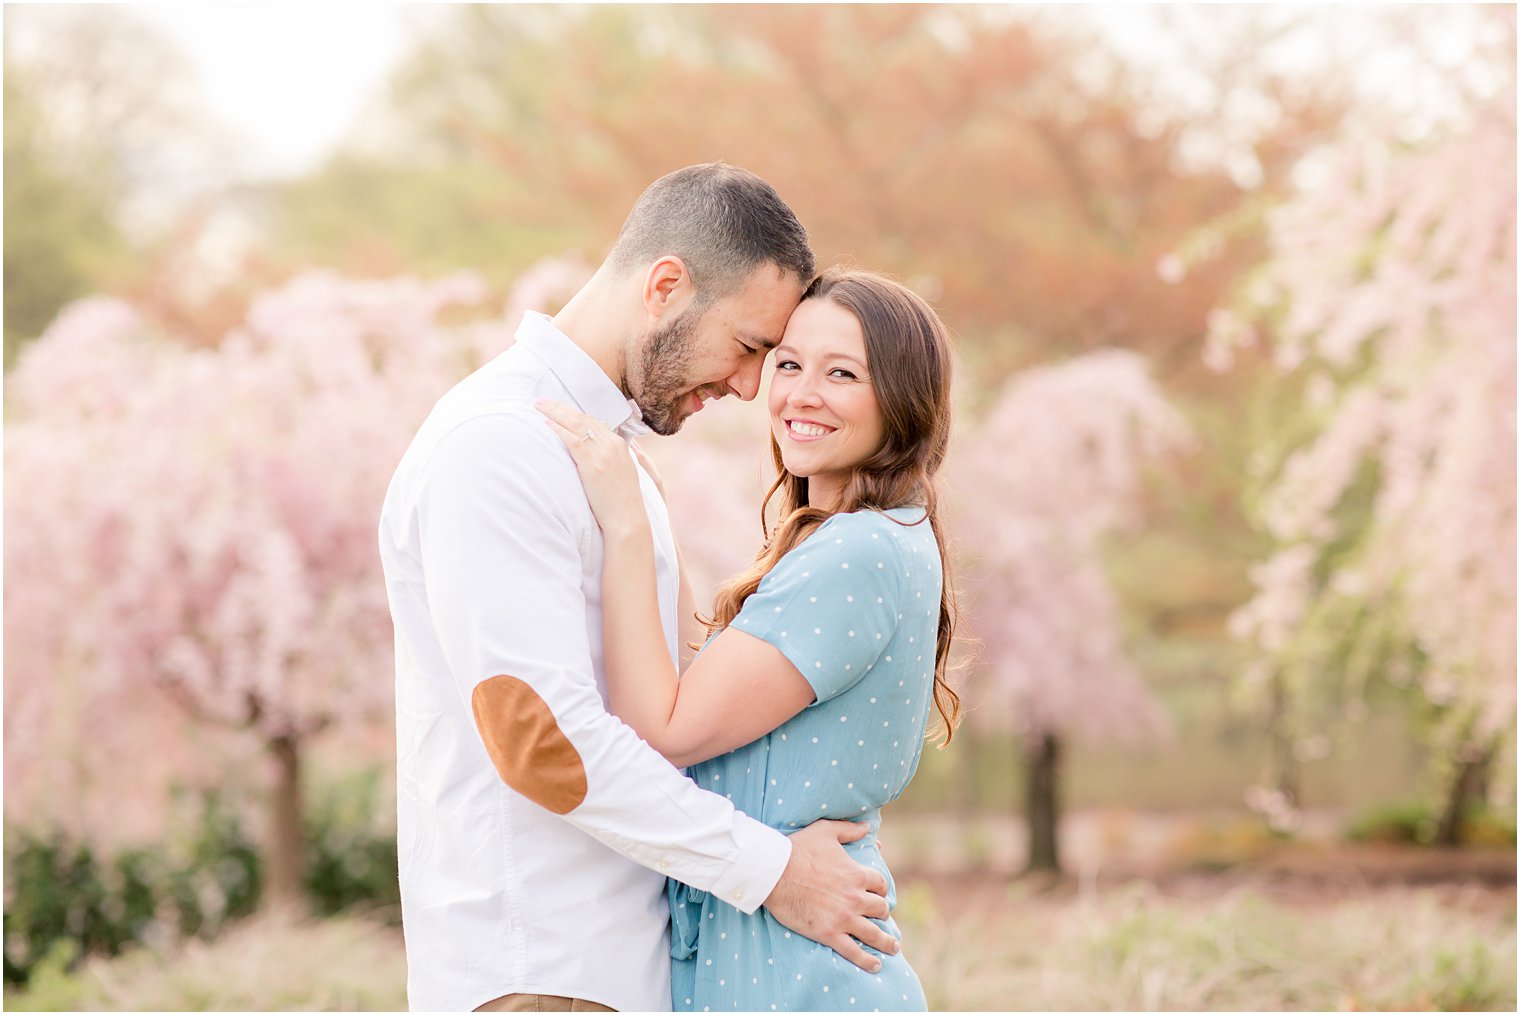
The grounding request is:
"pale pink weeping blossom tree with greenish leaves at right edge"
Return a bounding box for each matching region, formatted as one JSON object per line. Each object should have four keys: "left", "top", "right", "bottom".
{"left": 1210, "top": 9, "right": 1515, "bottom": 842}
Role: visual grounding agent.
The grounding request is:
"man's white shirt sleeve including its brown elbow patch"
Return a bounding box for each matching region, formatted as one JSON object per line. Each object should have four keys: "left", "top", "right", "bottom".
{"left": 416, "top": 409, "right": 790, "bottom": 912}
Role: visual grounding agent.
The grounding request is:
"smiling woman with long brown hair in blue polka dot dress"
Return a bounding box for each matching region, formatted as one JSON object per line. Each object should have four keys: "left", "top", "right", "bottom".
{"left": 544, "top": 270, "right": 959, "bottom": 1010}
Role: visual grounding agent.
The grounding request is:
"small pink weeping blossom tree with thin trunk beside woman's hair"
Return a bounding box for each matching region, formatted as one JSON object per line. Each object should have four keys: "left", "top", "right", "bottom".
{"left": 950, "top": 351, "right": 1192, "bottom": 871}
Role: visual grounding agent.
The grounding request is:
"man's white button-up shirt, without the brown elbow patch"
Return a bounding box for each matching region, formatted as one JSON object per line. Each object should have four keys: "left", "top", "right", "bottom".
{"left": 380, "top": 313, "right": 790, "bottom": 1010}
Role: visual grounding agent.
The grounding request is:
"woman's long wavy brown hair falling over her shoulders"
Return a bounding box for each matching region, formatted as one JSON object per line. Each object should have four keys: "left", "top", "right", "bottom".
{"left": 702, "top": 269, "right": 961, "bottom": 746}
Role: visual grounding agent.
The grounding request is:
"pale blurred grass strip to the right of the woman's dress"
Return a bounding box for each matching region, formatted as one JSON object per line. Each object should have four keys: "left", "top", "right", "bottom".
{"left": 900, "top": 881, "right": 1515, "bottom": 1010}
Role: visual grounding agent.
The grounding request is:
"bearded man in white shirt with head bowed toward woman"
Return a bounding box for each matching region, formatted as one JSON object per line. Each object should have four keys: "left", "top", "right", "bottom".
{"left": 380, "top": 164, "right": 897, "bottom": 1010}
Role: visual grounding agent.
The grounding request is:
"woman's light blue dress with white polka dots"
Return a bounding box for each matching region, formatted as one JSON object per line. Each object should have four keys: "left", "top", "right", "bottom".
{"left": 669, "top": 508, "right": 942, "bottom": 1012}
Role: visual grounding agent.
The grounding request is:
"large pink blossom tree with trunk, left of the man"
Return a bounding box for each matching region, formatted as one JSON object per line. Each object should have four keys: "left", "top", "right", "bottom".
{"left": 5, "top": 263, "right": 585, "bottom": 901}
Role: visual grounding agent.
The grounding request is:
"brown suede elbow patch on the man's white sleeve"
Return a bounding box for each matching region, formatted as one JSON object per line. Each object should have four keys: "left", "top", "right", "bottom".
{"left": 470, "top": 675, "right": 587, "bottom": 814}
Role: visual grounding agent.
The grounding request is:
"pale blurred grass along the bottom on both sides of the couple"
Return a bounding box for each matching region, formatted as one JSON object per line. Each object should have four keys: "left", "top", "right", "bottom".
{"left": 6, "top": 877, "right": 1515, "bottom": 1010}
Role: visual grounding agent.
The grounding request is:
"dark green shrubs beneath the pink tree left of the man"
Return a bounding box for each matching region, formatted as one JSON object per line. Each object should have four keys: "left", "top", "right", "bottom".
{"left": 5, "top": 772, "right": 400, "bottom": 983}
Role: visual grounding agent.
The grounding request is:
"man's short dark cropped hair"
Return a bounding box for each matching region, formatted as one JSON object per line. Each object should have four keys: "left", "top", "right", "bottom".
{"left": 606, "top": 163, "right": 813, "bottom": 304}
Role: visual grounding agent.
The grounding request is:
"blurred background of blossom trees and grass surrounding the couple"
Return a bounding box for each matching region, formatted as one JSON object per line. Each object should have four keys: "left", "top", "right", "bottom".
{"left": 3, "top": 5, "right": 1515, "bottom": 1010}
